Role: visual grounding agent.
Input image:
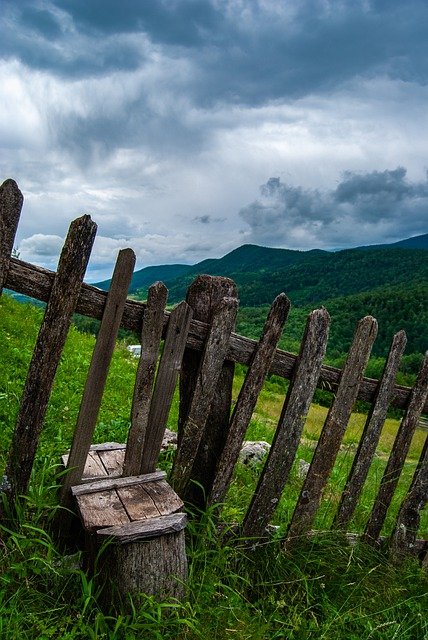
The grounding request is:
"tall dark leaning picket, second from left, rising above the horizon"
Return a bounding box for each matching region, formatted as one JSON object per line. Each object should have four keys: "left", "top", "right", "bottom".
{"left": 1, "top": 216, "right": 97, "bottom": 505}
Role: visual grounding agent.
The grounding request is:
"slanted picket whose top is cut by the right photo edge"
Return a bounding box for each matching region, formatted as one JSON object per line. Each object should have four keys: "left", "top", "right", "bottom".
{"left": 364, "top": 352, "right": 428, "bottom": 543}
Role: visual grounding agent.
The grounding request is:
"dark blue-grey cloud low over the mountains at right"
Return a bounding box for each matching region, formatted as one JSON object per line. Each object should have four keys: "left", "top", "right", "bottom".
{"left": 240, "top": 167, "right": 428, "bottom": 247}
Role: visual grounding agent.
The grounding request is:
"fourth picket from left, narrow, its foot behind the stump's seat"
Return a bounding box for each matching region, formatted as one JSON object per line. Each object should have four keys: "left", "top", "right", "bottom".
{"left": 123, "top": 282, "right": 168, "bottom": 476}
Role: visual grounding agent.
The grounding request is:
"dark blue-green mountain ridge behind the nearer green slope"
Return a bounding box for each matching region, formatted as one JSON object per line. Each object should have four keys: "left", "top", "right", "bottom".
{"left": 96, "top": 234, "right": 428, "bottom": 306}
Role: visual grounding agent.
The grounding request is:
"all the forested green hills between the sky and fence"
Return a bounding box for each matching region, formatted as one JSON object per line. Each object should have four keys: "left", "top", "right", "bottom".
{"left": 89, "top": 234, "right": 428, "bottom": 356}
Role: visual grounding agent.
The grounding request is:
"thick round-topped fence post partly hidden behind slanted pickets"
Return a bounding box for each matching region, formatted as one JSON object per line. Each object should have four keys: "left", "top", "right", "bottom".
{"left": 178, "top": 275, "right": 237, "bottom": 508}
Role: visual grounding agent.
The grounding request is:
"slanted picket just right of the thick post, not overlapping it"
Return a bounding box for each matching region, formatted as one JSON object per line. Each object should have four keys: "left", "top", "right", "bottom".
{"left": 208, "top": 293, "right": 290, "bottom": 505}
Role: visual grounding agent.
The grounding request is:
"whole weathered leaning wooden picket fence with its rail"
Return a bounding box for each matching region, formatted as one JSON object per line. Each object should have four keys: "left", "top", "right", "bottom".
{"left": 0, "top": 180, "right": 428, "bottom": 558}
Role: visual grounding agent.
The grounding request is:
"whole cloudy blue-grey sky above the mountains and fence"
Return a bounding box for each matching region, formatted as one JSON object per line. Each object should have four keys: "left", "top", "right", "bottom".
{"left": 0, "top": 0, "right": 428, "bottom": 281}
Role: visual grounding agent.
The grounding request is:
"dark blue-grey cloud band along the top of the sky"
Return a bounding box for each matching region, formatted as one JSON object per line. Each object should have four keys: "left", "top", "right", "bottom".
{"left": 2, "top": 0, "right": 428, "bottom": 99}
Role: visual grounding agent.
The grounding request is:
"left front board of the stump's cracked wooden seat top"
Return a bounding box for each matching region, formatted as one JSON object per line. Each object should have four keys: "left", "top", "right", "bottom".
{"left": 77, "top": 490, "right": 129, "bottom": 531}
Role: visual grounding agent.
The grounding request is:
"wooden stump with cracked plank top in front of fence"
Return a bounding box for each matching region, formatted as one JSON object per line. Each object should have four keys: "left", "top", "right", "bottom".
{"left": 72, "top": 471, "right": 187, "bottom": 605}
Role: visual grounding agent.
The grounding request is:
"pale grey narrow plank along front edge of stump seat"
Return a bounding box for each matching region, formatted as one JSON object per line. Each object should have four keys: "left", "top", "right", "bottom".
{"left": 97, "top": 513, "right": 187, "bottom": 544}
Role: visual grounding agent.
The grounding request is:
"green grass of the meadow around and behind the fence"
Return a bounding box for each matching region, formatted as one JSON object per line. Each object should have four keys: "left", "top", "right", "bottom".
{"left": 0, "top": 296, "right": 428, "bottom": 640}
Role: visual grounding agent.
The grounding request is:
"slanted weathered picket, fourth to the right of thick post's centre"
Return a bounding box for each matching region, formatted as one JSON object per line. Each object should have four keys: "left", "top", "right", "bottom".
{"left": 287, "top": 316, "right": 377, "bottom": 539}
